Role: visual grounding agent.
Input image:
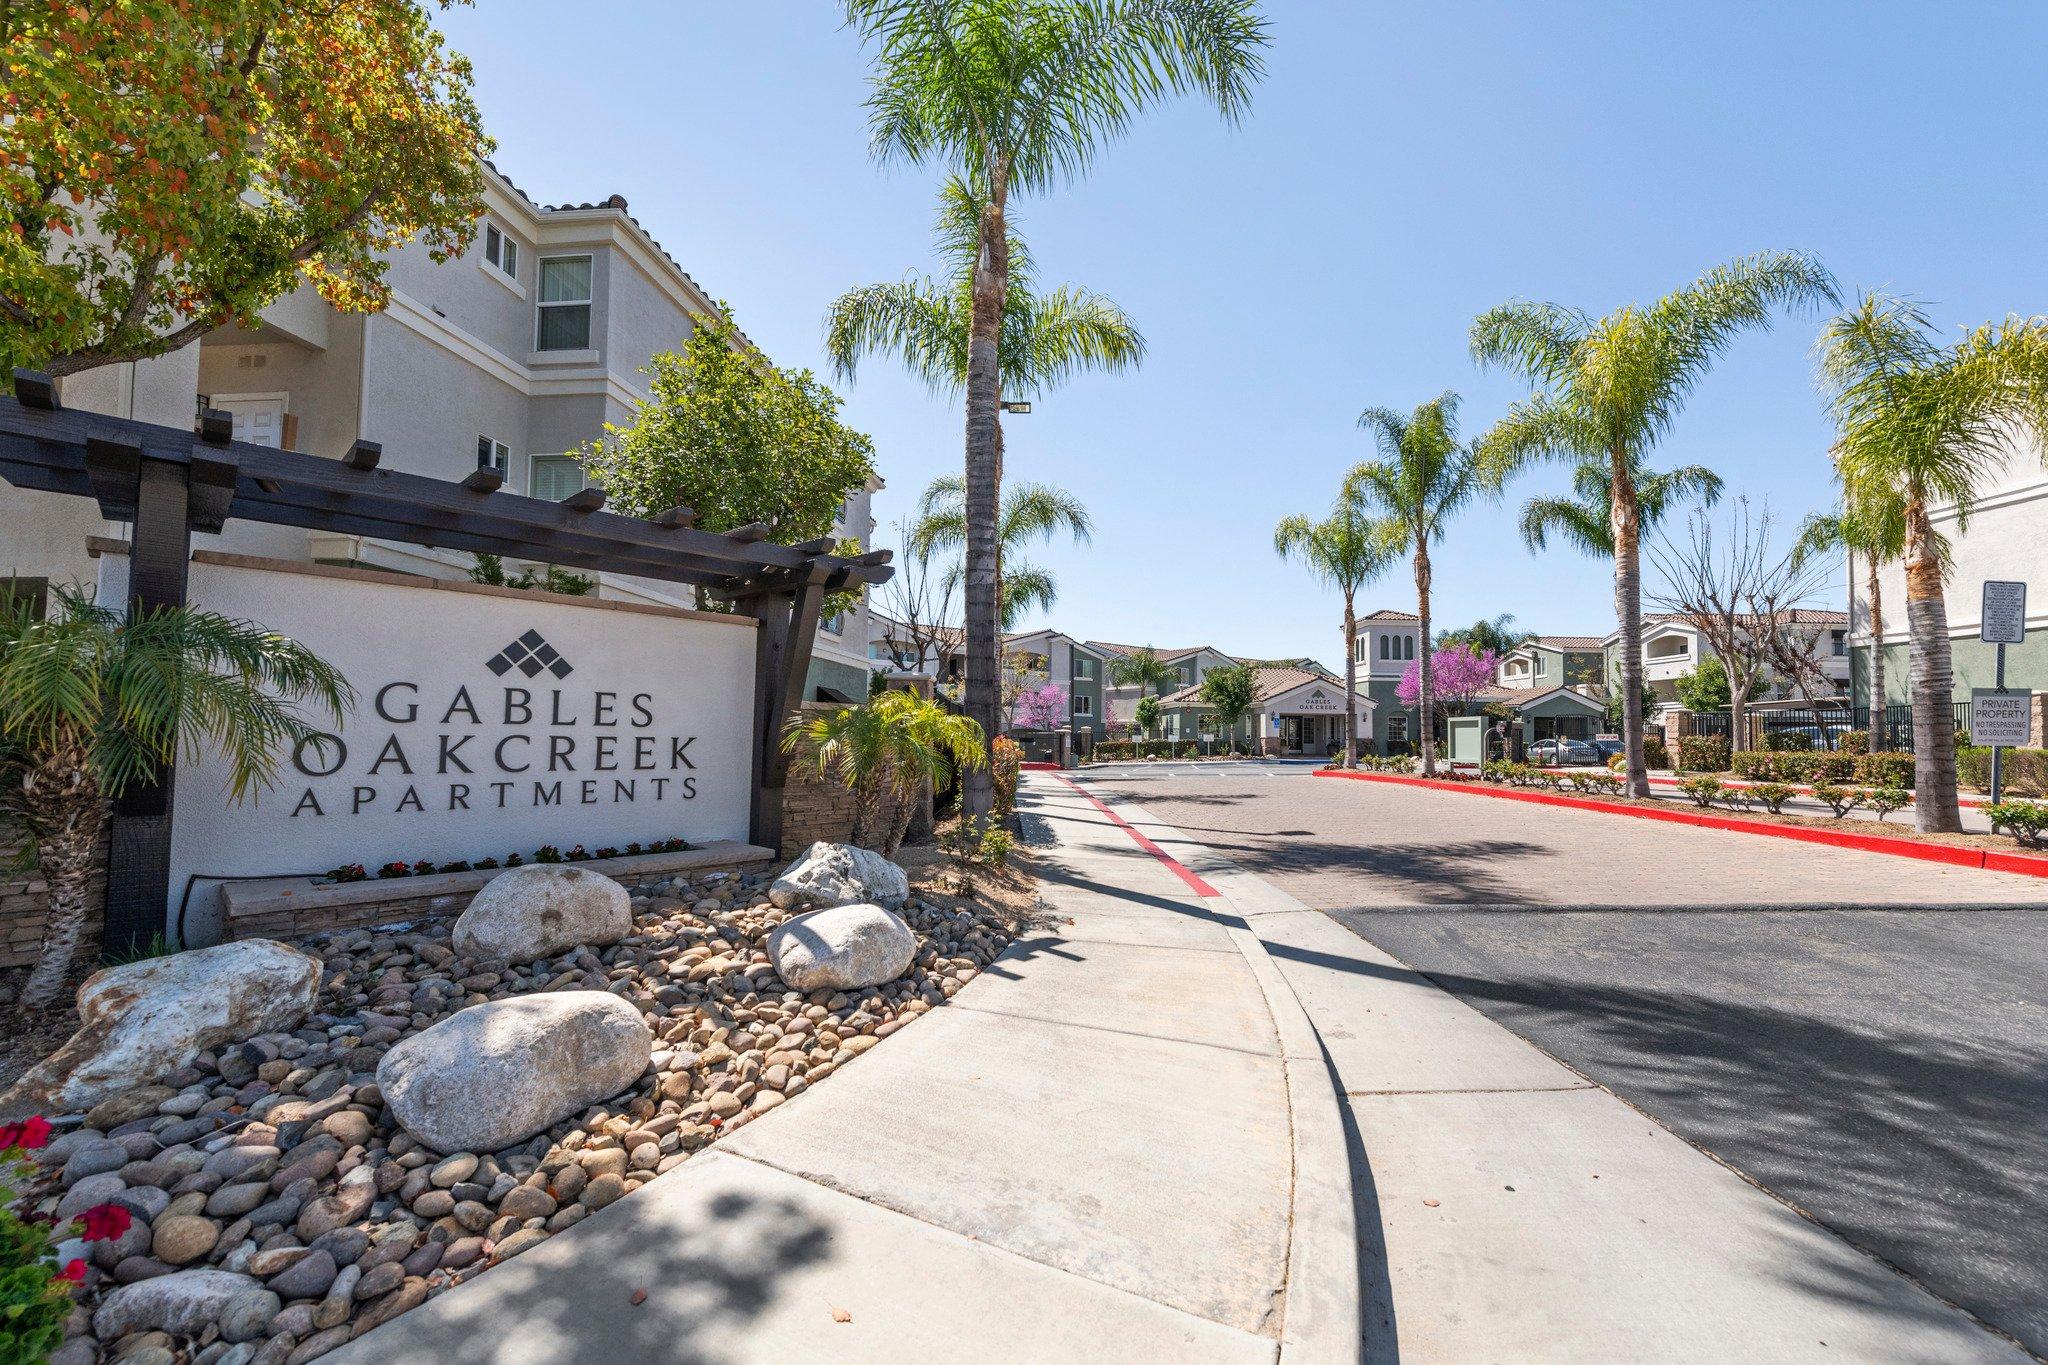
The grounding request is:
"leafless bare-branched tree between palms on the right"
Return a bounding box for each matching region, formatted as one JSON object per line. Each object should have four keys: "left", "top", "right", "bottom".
{"left": 1649, "top": 497, "right": 1827, "bottom": 747}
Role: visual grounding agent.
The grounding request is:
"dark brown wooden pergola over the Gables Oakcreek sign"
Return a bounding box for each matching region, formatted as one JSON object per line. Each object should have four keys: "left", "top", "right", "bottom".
{"left": 0, "top": 370, "right": 895, "bottom": 952}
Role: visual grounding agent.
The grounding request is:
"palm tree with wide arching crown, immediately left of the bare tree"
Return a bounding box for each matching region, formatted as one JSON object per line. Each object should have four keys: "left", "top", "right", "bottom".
{"left": 1473, "top": 252, "right": 1835, "bottom": 796}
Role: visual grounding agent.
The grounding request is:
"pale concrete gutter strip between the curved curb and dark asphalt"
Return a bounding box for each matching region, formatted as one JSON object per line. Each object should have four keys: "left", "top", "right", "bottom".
{"left": 1089, "top": 773, "right": 2028, "bottom": 1361}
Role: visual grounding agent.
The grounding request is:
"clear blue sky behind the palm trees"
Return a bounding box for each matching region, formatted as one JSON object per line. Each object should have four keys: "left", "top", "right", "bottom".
{"left": 442, "top": 0, "right": 2048, "bottom": 665}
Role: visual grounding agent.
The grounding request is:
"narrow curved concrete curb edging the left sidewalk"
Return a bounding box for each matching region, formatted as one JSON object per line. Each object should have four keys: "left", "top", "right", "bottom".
{"left": 1040, "top": 776, "right": 1364, "bottom": 1365}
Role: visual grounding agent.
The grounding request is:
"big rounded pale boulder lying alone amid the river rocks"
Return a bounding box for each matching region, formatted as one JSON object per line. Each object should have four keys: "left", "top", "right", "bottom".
{"left": 377, "top": 990, "right": 653, "bottom": 1152}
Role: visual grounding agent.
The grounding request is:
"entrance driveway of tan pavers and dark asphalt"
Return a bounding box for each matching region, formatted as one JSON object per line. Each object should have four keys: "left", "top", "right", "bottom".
{"left": 1090, "top": 765, "right": 2048, "bottom": 1355}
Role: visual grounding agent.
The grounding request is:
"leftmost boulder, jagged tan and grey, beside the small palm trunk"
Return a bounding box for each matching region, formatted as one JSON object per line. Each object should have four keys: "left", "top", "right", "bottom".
{"left": 0, "top": 939, "right": 319, "bottom": 1115}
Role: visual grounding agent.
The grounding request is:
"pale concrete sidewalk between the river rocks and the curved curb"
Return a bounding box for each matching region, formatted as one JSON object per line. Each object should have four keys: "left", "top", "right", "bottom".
{"left": 330, "top": 776, "right": 1360, "bottom": 1365}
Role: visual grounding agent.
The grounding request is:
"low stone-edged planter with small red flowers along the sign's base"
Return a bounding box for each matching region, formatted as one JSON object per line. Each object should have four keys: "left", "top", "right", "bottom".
{"left": 221, "top": 841, "right": 774, "bottom": 939}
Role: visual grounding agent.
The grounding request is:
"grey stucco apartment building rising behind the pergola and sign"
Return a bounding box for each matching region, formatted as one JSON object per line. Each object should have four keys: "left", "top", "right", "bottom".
{"left": 0, "top": 164, "right": 881, "bottom": 698}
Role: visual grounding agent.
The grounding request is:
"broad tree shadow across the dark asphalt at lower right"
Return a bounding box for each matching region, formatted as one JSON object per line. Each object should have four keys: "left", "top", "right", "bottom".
{"left": 1360, "top": 964, "right": 2048, "bottom": 1353}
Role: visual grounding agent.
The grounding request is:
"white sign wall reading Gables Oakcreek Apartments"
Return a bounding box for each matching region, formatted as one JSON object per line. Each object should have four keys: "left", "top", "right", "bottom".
{"left": 100, "top": 557, "right": 754, "bottom": 939}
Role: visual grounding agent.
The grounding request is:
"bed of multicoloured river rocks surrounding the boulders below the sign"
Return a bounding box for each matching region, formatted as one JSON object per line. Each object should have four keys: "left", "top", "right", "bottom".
{"left": 33, "top": 845, "right": 1032, "bottom": 1365}
